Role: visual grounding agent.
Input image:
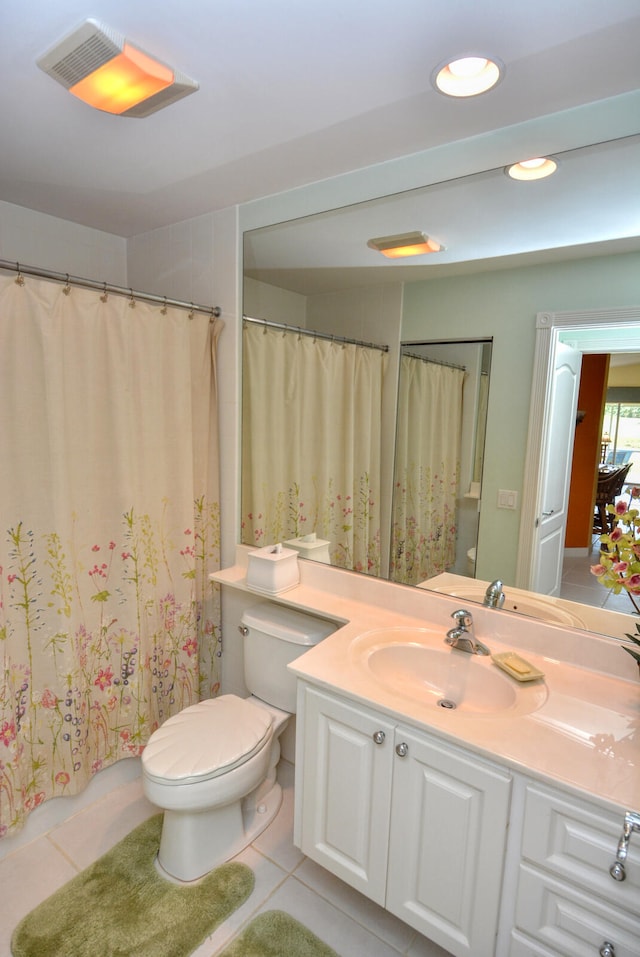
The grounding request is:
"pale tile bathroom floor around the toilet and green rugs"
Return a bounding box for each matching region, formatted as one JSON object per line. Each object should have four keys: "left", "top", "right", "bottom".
{"left": 0, "top": 761, "right": 449, "bottom": 957}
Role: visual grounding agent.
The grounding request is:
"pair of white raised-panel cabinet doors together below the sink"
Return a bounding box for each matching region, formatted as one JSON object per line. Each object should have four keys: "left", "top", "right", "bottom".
{"left": 296, "top": 683, "right": 511, "bottom": 957}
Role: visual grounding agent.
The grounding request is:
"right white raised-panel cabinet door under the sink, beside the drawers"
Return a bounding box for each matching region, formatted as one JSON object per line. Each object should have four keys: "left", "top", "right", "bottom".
{"left": 387, "top": 728, "right": 511, "bottom": 957}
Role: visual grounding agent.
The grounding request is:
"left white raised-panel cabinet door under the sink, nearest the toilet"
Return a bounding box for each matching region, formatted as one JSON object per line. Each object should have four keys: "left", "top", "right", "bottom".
{"left": 296, "top": 688, "right": 393, "bottom": 905}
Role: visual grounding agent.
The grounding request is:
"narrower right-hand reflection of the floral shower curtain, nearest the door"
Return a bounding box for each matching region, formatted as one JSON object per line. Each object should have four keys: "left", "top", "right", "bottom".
{"left": 391, "top": 355, "right": 464, "bottom": 585}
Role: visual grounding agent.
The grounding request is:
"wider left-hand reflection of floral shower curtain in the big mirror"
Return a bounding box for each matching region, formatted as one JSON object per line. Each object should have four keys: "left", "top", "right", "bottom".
{"left": 242, "top": 323, "right": 386, "bottom": 575}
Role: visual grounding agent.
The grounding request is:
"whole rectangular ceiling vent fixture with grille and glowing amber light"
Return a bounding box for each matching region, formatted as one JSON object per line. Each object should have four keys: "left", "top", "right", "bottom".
{"left": 37, "top": 20, "right": 198, "bottom": 117}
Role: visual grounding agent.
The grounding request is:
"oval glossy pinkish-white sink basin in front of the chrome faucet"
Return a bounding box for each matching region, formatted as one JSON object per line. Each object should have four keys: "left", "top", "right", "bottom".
{"left": 351, "top": 628, "right": 547, "bottom": 715}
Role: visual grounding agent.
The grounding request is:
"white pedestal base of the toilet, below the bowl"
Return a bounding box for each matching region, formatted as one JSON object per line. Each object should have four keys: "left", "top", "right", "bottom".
{"left": 156, "top": 782, "right": 282, "bottom": 884}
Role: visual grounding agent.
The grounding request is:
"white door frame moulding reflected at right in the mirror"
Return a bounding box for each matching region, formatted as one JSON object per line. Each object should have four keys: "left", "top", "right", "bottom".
{"left": 516, "top": 306, "right": 640, "bottom": 589}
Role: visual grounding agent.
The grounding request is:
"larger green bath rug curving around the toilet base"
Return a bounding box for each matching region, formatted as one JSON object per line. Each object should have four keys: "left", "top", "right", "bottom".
{"left": 11, "top": 814, "right": 254, "bottom": 957}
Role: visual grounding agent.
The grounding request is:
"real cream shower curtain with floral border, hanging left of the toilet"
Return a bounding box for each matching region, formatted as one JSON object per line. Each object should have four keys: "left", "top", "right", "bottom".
{"left": 0, "top": 276, "right": 220, "bottom": 836}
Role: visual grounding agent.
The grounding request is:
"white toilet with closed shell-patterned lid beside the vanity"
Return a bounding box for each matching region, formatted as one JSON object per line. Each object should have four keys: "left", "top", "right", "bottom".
{"left": 142, "top": 602, "right": 335, "bottom": 881}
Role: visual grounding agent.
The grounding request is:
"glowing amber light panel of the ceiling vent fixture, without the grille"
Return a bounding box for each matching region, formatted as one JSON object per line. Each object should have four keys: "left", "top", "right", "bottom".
{"left": 69, "top": 43, "right": 174, "bottom": 114}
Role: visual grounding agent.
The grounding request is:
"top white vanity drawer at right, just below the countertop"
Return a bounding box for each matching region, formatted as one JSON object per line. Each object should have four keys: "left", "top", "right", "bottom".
{"left": 522, "top": 785, "right": 640, "bottom": 917}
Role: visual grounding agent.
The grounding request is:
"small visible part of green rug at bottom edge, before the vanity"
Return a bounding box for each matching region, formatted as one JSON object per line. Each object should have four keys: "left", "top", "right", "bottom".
{"left": 221, "top": 910, "right": 338, "bottom": 957}
